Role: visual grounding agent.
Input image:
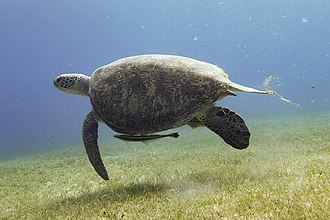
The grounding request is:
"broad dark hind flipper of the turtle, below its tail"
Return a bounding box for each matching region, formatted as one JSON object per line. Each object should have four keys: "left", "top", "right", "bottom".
{"left": 198, "top": 107, "right": 250, "bottom": 149}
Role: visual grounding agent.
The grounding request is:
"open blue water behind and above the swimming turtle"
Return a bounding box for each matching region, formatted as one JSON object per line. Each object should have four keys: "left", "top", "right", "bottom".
{"left": 0, "top": 0, "right": 330, "bottom": 159}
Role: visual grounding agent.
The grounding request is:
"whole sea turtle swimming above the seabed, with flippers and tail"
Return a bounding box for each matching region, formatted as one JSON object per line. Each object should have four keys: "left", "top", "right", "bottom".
{"left": 54, "top": 54, "right": 268, "bottom": 180}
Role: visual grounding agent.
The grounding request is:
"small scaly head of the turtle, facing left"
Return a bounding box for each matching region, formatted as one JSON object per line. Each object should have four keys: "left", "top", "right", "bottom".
{"left": 54, "top": 73, "right": 90, "bottom": 96}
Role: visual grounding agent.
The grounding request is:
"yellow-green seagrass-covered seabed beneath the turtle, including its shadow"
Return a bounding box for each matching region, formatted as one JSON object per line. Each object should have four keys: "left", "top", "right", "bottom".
{"left": 0, "top": 113, "right": 330, "bottom": 219}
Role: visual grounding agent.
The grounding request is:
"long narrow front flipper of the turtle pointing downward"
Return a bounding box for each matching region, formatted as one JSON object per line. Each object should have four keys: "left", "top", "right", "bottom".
{"left": 82, "top": 112, "right": 109, "bottom": 180}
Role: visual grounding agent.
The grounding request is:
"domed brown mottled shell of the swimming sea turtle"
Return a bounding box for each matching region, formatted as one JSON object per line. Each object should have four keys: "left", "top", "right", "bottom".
{"left": 89, "top": 55, "right": 230, "bottom": 135}
